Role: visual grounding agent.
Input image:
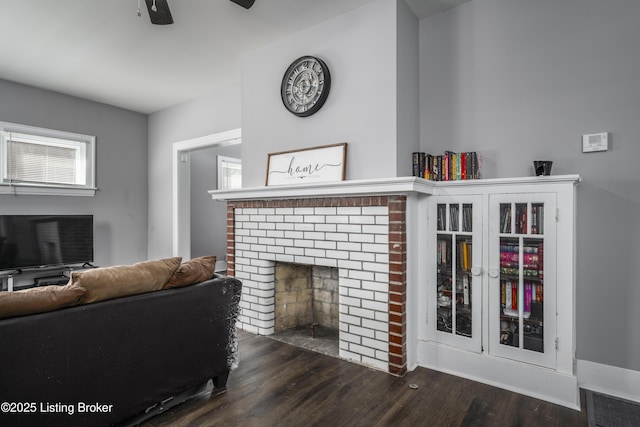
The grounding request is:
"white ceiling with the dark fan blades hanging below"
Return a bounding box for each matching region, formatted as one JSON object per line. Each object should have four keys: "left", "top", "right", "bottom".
{"left": 0, "top": 0, "right": 468, "bottom": 113}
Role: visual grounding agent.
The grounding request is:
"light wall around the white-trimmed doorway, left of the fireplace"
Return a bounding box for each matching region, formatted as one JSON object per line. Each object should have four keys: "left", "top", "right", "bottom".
{"left": 148, "top": 86, "right": 240, "bottom": 259}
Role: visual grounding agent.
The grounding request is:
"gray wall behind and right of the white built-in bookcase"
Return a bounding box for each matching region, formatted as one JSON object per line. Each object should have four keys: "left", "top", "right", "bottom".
{"left": 420, "top": 0, "right": 640, "bottom": 371}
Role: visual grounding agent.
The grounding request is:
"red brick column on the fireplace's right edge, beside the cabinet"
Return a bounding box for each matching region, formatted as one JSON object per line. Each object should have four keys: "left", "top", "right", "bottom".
{"left": 389, "top": 196, "right": 407, "bottom": 375}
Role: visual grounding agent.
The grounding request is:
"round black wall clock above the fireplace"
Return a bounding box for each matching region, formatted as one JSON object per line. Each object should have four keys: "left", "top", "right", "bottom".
{"left": 280, "top": 56, "right": 331, "bottom": 117}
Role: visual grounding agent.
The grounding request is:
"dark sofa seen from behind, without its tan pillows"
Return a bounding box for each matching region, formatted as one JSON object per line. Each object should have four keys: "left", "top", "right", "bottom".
{"left": 0, "top": 277, "right": 241, "bottom": 426}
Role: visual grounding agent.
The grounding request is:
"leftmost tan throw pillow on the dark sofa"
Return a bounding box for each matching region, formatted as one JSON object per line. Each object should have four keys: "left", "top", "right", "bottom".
{"left": 0, "top": 284, "right": 86, "bottom": 319}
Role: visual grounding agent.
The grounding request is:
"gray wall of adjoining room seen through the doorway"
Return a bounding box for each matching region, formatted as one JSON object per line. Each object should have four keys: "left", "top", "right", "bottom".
{"left": 190, "top": 145, "right": 240, "bottom": 261}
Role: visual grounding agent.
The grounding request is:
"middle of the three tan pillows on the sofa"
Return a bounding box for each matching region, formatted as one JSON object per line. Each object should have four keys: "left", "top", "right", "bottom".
{"left": 71, "top": 257, "right": 182, "bottom": 304}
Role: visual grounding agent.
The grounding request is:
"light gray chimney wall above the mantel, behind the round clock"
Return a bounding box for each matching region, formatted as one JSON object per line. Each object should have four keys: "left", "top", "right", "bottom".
{"left": 242, "top": 0, "right": 402, "bottom": 187}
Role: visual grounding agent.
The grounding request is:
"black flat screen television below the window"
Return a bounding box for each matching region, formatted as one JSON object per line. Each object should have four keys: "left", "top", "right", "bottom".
{"left": 0, "top": 215, "right": 93, "bottom": 270}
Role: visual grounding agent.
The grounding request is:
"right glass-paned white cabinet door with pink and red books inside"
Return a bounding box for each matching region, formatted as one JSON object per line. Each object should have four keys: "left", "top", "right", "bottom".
{"left": 489, "top": 195, "right": 555, "bottom": 366}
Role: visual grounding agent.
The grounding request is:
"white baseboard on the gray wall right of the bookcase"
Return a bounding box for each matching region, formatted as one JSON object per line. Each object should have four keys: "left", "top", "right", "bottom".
{"left": 578, "top": 360, "right": 640, "bottom": 402}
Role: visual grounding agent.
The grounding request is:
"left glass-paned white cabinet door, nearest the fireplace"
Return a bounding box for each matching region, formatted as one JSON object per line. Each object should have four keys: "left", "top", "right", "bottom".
{"left": 430, "top": 197, "right": 481, "bottom": 351}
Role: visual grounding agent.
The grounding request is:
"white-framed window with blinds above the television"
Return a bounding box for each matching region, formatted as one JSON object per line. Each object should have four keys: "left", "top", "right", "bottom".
{"left": 0, "top": 123, "right": 94, "bottom": 196}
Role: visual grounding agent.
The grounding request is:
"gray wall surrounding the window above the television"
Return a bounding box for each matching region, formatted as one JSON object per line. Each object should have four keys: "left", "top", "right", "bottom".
{"left": 0, "top": 80, "right": 147, "bottom": 266}
